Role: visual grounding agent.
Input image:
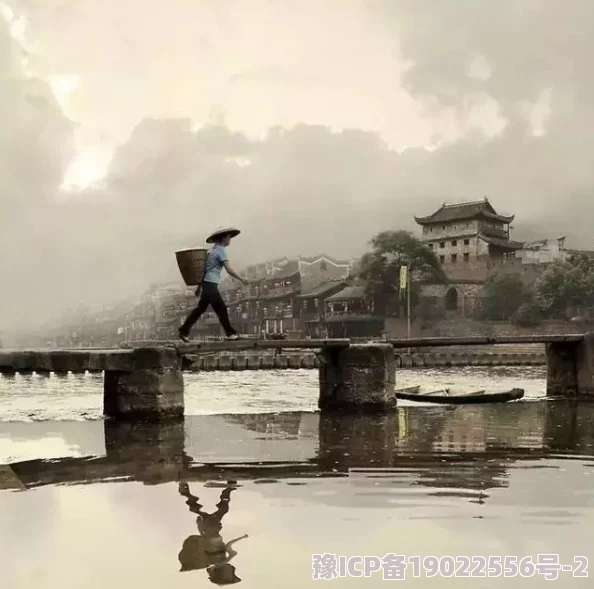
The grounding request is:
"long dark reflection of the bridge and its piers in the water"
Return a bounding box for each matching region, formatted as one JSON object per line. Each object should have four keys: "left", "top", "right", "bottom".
{"left": 4, "top": 402, "right": 594, "bottom": 500}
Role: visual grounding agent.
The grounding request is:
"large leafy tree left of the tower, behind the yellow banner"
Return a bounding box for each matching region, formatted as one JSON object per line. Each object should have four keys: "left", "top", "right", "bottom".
{"left": 359, "top": 231, "right": 446, "bottom": 314}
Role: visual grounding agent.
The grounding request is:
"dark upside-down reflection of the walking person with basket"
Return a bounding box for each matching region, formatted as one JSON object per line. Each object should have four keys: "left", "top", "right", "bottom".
{"left": 178, "top": 482, "right": 248, "bottom": 585}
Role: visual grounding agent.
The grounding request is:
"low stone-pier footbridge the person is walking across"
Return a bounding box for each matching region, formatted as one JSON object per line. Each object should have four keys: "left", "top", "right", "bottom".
{"left": 0, "top": 334, "right": 594, "bottom": 419}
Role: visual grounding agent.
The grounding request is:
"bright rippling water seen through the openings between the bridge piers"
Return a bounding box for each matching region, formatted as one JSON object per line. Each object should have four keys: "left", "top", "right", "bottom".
{"left": 0, "top": 366, "right": 546, "bottom": 420}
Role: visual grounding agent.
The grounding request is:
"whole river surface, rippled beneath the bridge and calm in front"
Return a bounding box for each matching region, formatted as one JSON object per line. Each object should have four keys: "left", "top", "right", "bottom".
{"left": 0, "top": 367, "right": 594, "bottom": 589}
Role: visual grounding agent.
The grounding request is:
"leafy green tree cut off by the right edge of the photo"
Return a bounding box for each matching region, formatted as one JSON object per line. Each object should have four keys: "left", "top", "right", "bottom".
{"left": 536, "top": 254, "right": 594, "bottom": 318}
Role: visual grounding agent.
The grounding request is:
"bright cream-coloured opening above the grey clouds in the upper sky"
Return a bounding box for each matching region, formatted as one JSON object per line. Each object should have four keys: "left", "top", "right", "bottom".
{"left": 13, "top": 0, "right": 500, "bottom": 184}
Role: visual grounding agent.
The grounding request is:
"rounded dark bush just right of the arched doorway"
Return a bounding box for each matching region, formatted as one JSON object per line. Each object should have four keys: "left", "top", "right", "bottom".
{"left": 483, "top": 273, "right": 532, "bottom": 321}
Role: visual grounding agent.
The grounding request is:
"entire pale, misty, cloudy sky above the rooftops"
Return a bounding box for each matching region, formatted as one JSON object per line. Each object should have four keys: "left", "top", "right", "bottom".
{"left": 0, "top": 0, "right": 594, "bottom": 331}
